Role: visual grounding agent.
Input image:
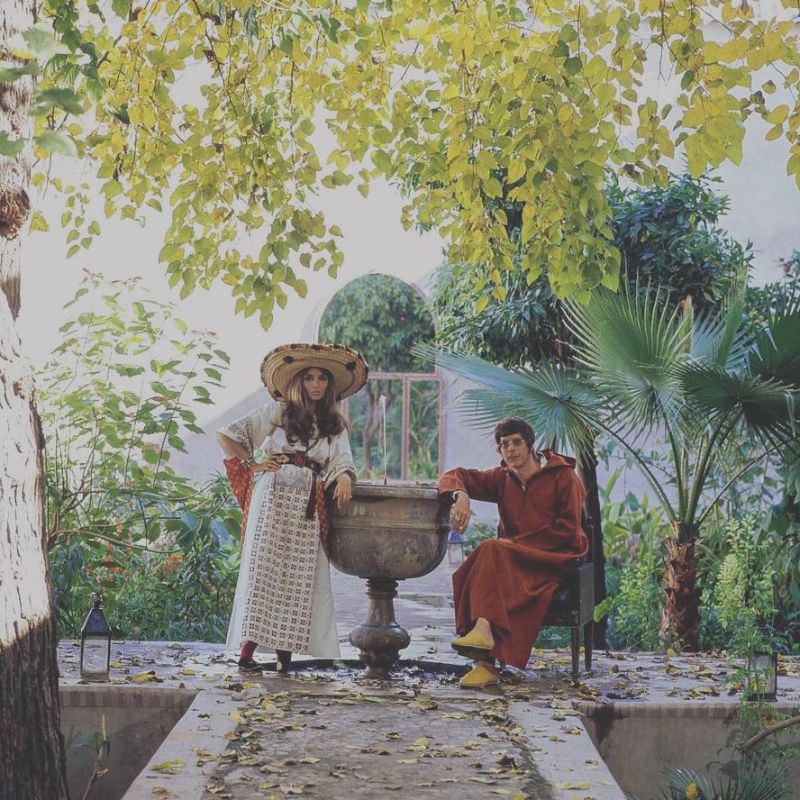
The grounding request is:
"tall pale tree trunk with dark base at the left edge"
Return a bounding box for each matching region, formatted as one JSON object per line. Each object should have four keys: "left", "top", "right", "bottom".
{"left": 0, "top": 0, "right": 68, "bottom": 800}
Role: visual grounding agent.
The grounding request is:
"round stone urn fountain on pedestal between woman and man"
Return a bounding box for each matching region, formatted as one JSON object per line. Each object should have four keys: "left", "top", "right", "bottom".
{"left": 328, "top": 483, "right": 451, "bottom": 679}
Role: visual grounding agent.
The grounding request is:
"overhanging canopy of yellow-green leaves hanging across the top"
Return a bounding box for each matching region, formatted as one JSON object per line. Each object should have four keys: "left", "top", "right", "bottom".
{"left": 29, "top": 0, "right": 800, "bottom": 310}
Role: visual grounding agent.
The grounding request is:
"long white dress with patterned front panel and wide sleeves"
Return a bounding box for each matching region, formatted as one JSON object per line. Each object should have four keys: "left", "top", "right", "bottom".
{"left": 219, "top": 400, "right": 355, "bottom": 658}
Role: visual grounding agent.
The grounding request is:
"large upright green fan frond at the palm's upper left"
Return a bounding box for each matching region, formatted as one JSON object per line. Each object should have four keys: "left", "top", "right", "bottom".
{"left": 565, "top": 289, "right": 689, "bottom": 438}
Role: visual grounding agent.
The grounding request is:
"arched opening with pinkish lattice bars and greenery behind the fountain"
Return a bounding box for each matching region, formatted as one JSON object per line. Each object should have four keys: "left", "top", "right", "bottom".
{"left": 318, "top": 274, "right": 444, "bottom": 480}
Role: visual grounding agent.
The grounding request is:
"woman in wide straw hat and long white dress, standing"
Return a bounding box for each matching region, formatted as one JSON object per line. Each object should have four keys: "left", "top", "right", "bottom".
{"left": 217, "top": 344, "right": 368, "bottom": 671}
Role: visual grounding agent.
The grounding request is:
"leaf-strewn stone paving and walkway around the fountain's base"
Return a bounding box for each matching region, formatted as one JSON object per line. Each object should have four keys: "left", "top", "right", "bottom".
{"left": 59, "top": 569, "right": 800, "bottom": 800}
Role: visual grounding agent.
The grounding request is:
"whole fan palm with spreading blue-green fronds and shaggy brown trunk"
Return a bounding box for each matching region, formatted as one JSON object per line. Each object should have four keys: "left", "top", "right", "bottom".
{"left": 429, "top": 288, "right": 800, "bottom": 650}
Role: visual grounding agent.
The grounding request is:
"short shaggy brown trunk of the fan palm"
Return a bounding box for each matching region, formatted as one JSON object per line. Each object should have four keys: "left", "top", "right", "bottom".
{"left": 659, "top": 523, "right": 700, "bottom": 652}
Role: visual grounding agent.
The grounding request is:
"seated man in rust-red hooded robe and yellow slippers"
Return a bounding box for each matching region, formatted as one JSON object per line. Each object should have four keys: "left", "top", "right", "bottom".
{"left": 439, "top": 417, "right": 589, "bottom": 689}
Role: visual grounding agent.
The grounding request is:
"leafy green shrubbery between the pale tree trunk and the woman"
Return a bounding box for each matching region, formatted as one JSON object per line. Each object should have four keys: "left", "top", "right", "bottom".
{"left": 39, "top": 274, "right": 242, "bottom": 641}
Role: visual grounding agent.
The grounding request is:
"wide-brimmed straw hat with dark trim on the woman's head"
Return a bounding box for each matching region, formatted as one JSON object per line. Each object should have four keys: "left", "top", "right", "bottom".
{"left": 261, "top": 343, "right": 369, "bottom": 400}
